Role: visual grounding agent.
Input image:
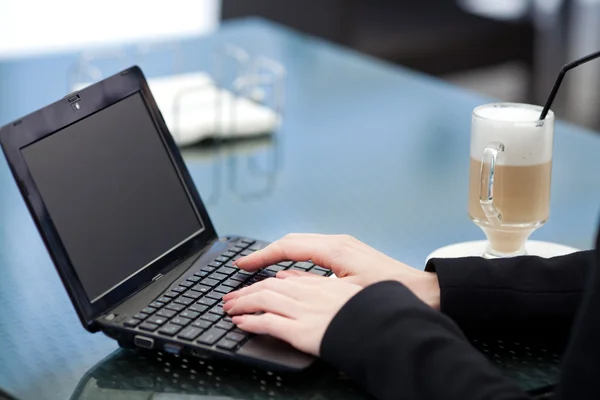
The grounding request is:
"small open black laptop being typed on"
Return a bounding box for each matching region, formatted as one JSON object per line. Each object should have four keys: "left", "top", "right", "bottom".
{"left": 0, "top": 66, "right": 330, "bottom": 371}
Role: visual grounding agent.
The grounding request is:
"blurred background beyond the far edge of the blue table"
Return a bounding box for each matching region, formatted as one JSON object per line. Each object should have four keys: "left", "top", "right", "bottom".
{"left": 0, "top": 0, "right": 600, "bottom": 130}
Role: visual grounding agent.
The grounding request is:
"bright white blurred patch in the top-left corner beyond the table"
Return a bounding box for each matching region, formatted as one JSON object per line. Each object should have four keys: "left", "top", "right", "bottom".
{"left": 0, "top": 0, "right": 221, "bottom": 59}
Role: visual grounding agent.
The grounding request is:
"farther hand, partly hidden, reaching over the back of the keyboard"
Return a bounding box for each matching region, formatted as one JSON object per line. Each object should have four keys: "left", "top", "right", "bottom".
{"left": 236, "top": 234, "right": 440, "bottom": 309}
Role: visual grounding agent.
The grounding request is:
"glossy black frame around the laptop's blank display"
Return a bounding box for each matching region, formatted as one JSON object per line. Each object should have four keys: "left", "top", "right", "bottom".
{"left": 0, "top": 66, "right": 217, "bottom": 331}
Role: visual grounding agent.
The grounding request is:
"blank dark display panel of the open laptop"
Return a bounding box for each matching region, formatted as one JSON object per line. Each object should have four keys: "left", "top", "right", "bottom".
{"left": 22, "top": 93, "right": 204, "bottom": 303}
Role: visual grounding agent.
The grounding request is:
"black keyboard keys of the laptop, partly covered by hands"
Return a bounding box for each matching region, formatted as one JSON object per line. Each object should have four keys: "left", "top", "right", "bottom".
{"left": 124, "top": 239, "right": 331, "bottom": 351}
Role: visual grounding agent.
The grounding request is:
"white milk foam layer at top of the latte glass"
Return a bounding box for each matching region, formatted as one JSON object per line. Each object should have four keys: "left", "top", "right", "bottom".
{"left": 471, "top": 103, "right": 554, "bottom": 166}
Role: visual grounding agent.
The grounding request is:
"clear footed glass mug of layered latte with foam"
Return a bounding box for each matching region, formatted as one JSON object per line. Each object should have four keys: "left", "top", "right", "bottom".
{"left": 469, "top": 103, "right": 554, "bottom": 258}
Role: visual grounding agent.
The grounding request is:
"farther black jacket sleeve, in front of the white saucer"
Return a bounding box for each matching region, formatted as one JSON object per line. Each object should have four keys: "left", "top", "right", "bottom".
{"left": 425, "top": 251, "right": 594, "bottom": 342}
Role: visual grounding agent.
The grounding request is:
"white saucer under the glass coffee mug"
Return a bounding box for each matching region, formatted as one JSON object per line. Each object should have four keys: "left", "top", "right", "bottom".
{"left": 425, "top": 240, "right": 579, "bottom": 262}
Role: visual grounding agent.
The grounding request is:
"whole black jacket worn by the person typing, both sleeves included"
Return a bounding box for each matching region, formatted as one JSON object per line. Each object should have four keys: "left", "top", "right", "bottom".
{"left": 321, "top": 230, "right": 600, "bottom": 400}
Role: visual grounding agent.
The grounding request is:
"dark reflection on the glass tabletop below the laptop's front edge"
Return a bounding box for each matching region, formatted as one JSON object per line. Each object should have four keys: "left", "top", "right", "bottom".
{"left": 71, "top": 349, "right": 372, "bottom": 400}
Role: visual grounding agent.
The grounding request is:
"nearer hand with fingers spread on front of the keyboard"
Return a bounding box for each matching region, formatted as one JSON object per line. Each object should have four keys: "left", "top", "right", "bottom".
{"left": 223, "top": 275, "right": 362, "bottom": 356}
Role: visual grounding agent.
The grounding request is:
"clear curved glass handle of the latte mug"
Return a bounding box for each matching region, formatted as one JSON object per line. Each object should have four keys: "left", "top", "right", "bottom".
{"left": 479, "top": 142, "right": 504, "bottom": 225}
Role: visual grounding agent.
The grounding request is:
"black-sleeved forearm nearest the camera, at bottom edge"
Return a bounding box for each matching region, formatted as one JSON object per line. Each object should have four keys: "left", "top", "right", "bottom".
{"left": 321, "top": 282, "right": 527, "bottom": 400}
